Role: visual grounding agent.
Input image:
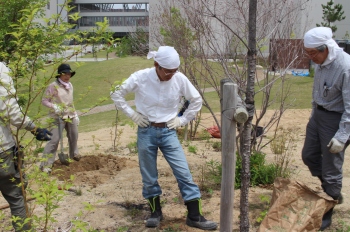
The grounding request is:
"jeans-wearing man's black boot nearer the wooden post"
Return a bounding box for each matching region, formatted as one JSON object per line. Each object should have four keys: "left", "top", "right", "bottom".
{"left": 185, "top": 199, "right": 217, "bottom": 230}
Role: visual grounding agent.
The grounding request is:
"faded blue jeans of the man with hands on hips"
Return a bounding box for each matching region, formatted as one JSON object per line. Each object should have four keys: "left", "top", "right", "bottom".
{"left": 137, "top": 126, "right": 201, "bottom": 202}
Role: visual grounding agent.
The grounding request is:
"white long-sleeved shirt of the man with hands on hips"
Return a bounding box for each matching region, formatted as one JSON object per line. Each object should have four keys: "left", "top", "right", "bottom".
{"left": 111, "top": 68, "right": 202, "bottom": 125}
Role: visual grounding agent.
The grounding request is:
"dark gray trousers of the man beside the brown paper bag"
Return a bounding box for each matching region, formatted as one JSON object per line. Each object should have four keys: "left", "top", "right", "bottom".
{"left": 302, "top": 109, "right": 348, "bottom": 198}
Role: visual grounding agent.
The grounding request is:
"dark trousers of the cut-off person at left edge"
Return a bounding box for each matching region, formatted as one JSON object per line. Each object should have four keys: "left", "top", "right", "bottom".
{"left": 0, "top": 148, "right": 30, "bottom": 232}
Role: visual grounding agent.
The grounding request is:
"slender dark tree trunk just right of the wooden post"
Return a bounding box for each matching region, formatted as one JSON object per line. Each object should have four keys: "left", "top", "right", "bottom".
{"left": 240, "top": 0, "right": 257, "bottom": 232}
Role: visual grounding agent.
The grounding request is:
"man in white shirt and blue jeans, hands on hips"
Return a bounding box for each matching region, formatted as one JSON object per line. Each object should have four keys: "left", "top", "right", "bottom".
{"left": 111, "top": 46, "right": 217, "bottom": 230}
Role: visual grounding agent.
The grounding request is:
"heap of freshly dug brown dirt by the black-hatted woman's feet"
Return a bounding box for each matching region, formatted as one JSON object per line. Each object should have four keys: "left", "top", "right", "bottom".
{"left": 52, "top": 154, "right": 137, "bottom": 188}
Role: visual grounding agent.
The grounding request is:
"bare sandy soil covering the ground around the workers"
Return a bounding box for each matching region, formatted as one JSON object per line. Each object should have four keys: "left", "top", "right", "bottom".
{"left": 0, "top": 110, "right": 350, "bottom": 231}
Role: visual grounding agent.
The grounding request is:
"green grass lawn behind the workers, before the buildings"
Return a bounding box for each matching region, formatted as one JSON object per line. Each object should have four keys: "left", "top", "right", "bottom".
{"left": 25, "top": 56, "right": 313, "bottom": 132}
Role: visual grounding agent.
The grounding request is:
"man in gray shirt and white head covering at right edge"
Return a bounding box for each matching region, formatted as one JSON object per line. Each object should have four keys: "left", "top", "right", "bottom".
{"left": 302, "top": 27, "right": 350, "bottom": 231}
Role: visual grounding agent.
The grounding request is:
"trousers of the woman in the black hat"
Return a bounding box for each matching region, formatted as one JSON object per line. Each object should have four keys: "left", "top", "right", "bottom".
{"left": 40, "top": 118, "right": 79, "bottom": 167}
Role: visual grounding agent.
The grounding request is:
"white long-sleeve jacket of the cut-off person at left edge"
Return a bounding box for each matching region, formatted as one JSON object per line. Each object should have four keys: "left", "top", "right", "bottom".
{"left": 0, "top": 62, "right": 35, "bottom": 153}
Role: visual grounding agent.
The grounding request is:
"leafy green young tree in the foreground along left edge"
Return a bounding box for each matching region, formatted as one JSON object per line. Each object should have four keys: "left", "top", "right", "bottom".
{"left": 0, "top": 0, "right": 113, "bottom": 231}
